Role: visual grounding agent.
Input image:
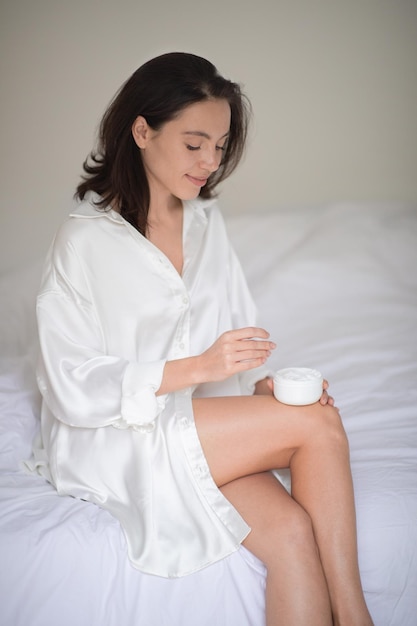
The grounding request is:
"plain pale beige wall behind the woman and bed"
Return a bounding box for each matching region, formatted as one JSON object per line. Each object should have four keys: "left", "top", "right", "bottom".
{"left": 0, "top": 0, "right": 417, "bottom": 271}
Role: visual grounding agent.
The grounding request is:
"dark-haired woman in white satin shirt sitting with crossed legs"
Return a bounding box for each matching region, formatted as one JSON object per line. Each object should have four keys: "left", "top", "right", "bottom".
{"left": 30, "top": 53, "right": 372, "bottom": 626}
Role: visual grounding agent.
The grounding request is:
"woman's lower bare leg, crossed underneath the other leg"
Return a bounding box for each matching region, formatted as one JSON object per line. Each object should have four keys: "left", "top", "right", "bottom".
{"left": 221, "top": 472, "right": 333, "bottom": 626}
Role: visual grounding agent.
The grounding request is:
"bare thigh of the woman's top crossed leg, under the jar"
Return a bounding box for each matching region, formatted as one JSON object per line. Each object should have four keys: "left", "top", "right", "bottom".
{"left": 193, "top": 396, "right": 341, "bottom": 486}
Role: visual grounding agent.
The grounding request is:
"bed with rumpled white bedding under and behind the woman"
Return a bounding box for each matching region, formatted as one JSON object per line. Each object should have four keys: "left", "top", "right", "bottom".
{"left": 0, "top": 204, "right": 417, "bottom": 626}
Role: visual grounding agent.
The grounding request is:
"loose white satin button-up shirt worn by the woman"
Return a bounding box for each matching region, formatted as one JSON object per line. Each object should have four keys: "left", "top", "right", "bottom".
{"left": 29, "top": 196, "right": 267, "bottom": 577}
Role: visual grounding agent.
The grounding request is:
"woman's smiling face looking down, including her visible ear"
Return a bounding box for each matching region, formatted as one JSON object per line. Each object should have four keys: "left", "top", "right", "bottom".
{"left": 132, "top": 100, "right": 230, "bottom": 203}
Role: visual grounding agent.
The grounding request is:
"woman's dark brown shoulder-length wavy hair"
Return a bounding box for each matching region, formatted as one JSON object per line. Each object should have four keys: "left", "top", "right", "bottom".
{"left": 75, "top": 52, "right": 250, "bottom": 234}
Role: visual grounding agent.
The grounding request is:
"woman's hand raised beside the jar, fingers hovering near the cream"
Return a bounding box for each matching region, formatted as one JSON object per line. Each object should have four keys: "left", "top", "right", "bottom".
{"left": 196, "top": 326, "right": 276, "bottom": 382}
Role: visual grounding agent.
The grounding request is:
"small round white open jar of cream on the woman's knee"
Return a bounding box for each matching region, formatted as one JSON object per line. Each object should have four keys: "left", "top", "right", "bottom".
{"left": 274, "top": 367, "right": 323, "bottom": 406}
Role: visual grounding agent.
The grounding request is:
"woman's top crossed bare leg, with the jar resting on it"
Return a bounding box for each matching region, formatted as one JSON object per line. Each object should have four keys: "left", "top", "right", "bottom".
{"left": 193, "top": 396, "right": 372, "bottom": 626}
